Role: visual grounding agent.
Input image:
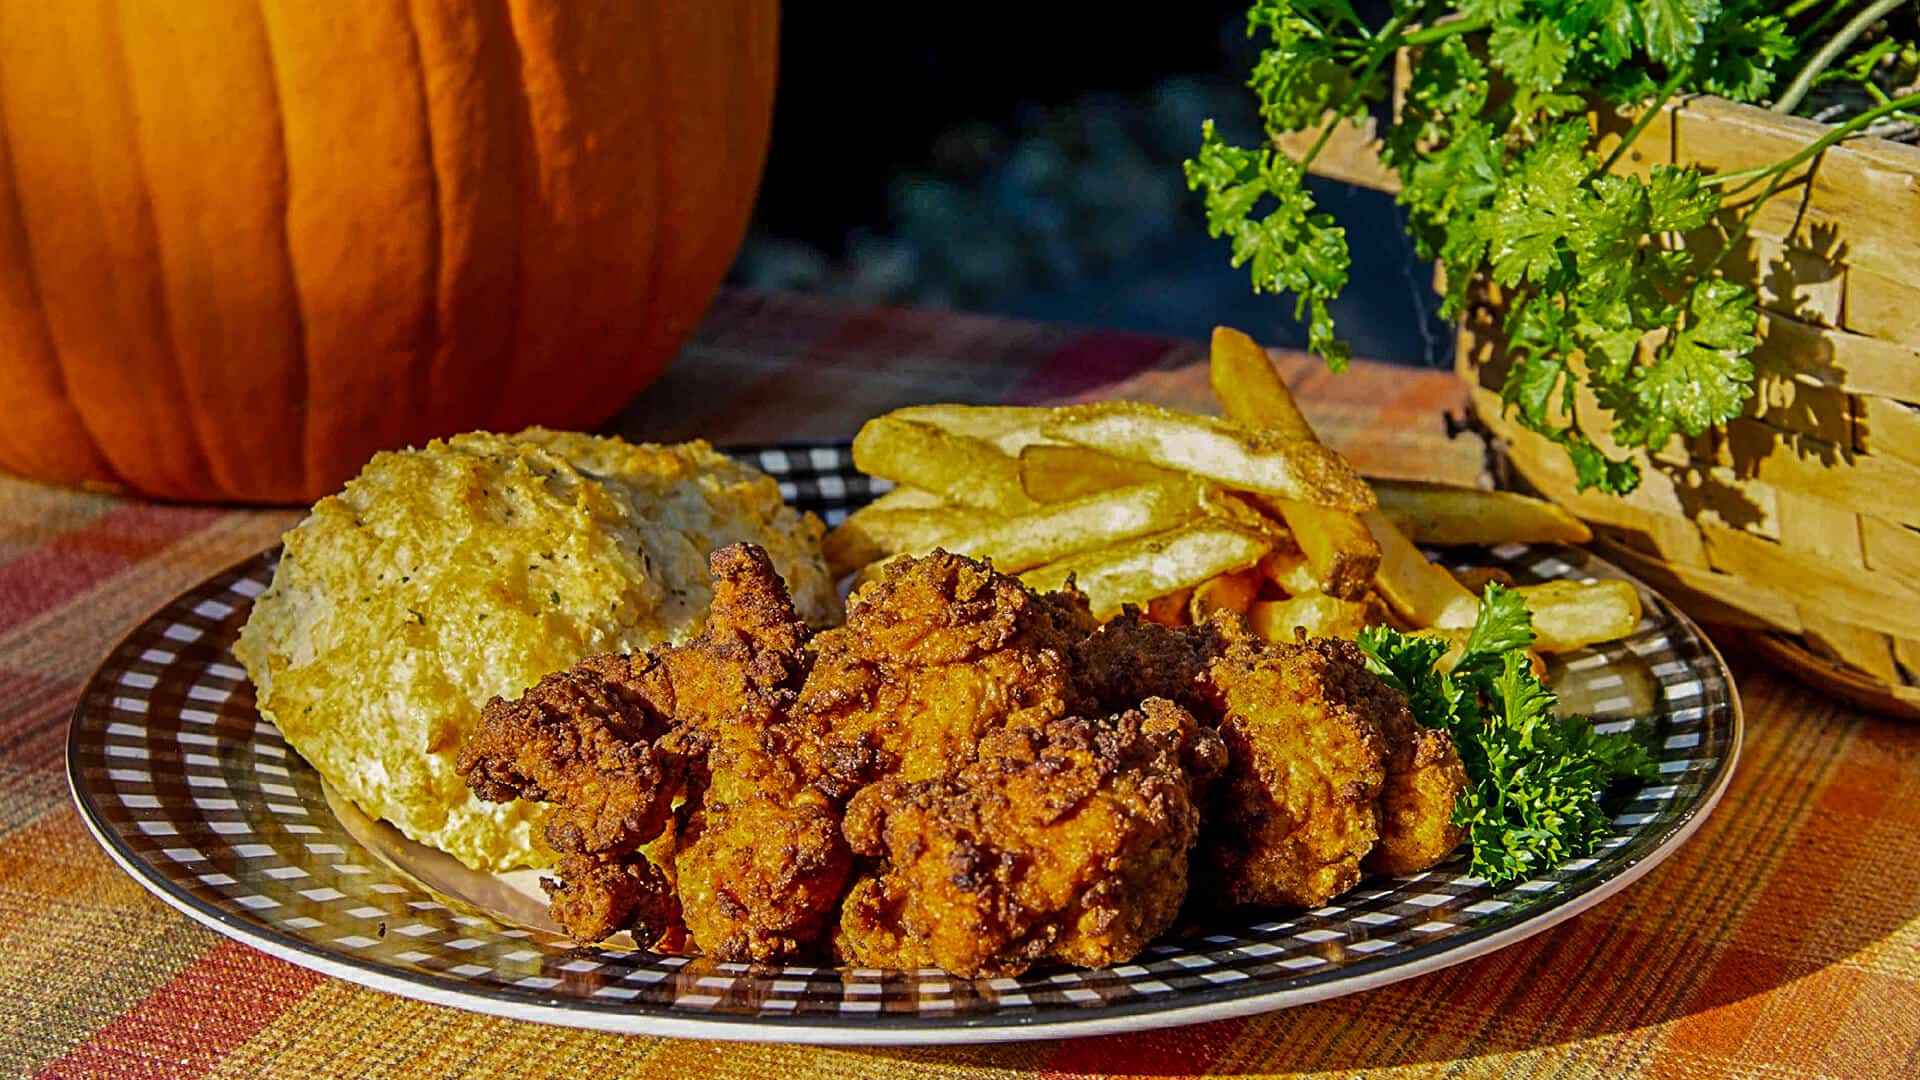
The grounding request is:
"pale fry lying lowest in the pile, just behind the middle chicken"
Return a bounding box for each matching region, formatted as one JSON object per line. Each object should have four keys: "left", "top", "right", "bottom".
{"left": 1020, "top": 521, "right": 1273, "bottom": 619}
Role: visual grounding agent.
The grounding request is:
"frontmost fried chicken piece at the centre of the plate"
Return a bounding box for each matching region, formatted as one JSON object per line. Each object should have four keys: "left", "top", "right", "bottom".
{"left": 837, "top": 700, "right": 1225, "bottom": 978}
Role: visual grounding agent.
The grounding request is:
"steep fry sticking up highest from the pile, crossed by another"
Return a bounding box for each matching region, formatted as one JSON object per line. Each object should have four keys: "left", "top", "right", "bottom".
{"left": 1208, "top": 327, "right": 1380, "bottom": 600}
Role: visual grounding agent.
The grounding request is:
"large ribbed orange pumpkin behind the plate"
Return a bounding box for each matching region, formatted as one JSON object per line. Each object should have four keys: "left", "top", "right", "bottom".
{"left": 0, "top": 0, "right": 778, "bottom": 502}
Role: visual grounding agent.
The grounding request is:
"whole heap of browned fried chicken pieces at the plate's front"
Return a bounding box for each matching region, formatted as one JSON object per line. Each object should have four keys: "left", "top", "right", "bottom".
{"left": 461, "top": 546, "right": 1457, "bottom": 976}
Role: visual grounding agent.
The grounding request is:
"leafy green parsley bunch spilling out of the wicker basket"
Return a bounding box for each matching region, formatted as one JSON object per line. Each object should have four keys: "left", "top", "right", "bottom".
{"left": 1187, "top": 0, "right": 1920, "bottom": 494}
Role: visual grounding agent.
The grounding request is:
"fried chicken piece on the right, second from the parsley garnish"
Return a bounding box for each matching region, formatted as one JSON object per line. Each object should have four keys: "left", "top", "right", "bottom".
{"left": 1208, "top": 638, "right": 1405, "bottom": 907}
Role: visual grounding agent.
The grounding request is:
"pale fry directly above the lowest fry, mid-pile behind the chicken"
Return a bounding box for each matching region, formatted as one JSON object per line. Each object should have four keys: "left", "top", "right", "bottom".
{"left": 912, "top": 479, "right": 1206, "bottom": 575}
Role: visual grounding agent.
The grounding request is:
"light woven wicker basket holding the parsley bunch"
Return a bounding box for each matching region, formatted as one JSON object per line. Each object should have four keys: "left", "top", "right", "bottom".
{"left": 1282, "top": 96, "right": 1920, "bottom": 719}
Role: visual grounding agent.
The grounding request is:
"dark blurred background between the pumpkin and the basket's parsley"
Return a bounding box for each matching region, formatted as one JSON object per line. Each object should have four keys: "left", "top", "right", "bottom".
{"left": 732, "top": 0, "right": 1450, "bottom": 365}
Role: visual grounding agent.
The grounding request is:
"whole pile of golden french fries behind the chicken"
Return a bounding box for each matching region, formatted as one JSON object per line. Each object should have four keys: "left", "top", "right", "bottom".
{"left": 826, "top": 327, "right": 1640, "bottom": 651}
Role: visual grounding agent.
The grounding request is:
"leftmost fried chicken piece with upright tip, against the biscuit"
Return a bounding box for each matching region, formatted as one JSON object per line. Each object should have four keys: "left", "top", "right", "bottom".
{"left": 461, "top": 544, "right": 851, "bottom": 959}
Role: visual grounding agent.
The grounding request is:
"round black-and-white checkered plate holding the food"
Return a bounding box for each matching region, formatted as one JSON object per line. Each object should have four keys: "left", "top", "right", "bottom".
{"left": 67, "top": 446, "right": 1740, "bottom": 1043}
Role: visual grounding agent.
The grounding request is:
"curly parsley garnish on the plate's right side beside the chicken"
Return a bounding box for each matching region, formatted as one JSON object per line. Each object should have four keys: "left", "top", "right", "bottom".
{"left": 1359, "top": 584, "right": 1657, "bottom": 886}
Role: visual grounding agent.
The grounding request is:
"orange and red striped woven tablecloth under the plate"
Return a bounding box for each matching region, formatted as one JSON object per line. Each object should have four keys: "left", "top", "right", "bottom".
{"left": 0, "top": 294, "right": 1920, "bottom": 1080}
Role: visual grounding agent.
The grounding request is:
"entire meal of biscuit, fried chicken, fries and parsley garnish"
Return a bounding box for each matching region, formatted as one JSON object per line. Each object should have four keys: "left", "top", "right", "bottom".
{"left": 242, "top": 317, "right": 1640, "bottom": 976}
